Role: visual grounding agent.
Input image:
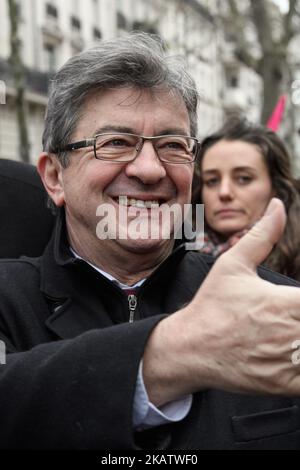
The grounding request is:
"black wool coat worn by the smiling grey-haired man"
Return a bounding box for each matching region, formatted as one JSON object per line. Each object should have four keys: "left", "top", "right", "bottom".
{"left": 0, "top": 211, "right": 300, "bottom": 450}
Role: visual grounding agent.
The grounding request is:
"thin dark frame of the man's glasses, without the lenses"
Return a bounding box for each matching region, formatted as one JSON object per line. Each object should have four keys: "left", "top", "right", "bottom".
{"left": 55, "top": 132, "right": 201, "bottom": 165}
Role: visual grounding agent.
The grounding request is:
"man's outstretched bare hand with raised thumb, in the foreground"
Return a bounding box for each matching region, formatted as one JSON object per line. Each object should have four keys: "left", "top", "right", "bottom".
{"left": 144, "top": 199, "right": 300, "bottom": 405}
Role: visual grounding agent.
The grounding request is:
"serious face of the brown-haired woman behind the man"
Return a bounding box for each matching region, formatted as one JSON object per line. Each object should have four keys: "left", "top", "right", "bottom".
{"left": 201, "top": 140, "right": 274, "bottom": 237}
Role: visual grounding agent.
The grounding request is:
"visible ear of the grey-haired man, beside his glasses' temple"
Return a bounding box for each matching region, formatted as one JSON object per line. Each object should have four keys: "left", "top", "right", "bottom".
{"left": 37, "top": 152, "right": 65, "bottom": 207}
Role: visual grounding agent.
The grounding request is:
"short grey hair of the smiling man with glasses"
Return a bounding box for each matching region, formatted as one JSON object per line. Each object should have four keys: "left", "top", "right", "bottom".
{"left": 43, "top": 33, "right": 198, "bottom": 166}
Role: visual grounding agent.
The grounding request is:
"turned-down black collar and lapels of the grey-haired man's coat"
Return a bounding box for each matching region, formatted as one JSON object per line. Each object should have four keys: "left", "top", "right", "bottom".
{"left": 39, "top": 210, "right": 211, "bottom": 339}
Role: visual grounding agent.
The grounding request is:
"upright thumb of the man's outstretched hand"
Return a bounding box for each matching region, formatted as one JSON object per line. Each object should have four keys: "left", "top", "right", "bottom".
{"left": 228, "top": 198, "right": 286, "bottom": 270}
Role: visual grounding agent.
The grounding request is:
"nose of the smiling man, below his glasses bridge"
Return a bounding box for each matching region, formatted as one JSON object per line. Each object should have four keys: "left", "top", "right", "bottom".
{"left": 125, "top": 141, "right": 167, "bottom": 184}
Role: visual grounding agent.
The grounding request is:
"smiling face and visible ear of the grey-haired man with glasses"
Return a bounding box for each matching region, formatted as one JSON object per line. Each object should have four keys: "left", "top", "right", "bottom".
{"left": 38, "top": 86, "right": 193, "bottom": 285}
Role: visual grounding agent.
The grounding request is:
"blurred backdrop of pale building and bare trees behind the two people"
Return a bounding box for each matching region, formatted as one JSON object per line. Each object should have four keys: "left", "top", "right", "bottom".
{"left": 0, "top": 0, "right": 300, "bottom": 175}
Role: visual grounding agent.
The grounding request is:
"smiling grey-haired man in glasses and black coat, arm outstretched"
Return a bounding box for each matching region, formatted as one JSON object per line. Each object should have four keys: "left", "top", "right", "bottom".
{"left": 0, "top": 34, "right": 300, "bottom": 449}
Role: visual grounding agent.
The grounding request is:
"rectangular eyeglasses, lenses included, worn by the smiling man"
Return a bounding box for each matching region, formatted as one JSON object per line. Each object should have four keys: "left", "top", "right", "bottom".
{"left": 59, "top": 132, "right": 200, "bottom": 164}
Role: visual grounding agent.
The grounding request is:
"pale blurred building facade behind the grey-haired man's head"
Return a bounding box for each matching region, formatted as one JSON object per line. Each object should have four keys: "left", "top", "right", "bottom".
{"left": 0, "top": 0, "right": 261, "bottom": 162}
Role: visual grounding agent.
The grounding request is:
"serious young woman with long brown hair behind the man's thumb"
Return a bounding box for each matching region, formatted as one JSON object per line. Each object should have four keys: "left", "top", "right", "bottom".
{"left": 193, "top": 119, "right": 300, "bottom": 280}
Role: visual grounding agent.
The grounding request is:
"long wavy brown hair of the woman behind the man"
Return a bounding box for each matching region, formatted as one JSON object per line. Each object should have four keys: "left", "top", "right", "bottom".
{"left": 192, "top": 118, "right": 300, "bottom": 280}
